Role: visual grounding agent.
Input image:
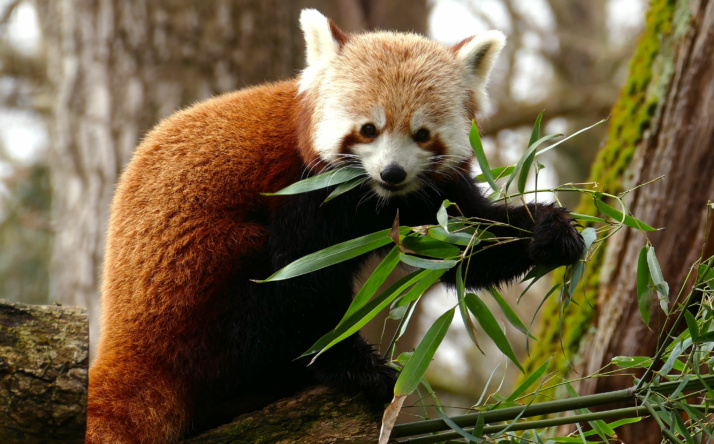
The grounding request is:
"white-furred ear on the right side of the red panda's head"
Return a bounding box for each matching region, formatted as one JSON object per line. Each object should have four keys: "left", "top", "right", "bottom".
{"left": 454, "top": 31, "right": 506, "bottom": 87}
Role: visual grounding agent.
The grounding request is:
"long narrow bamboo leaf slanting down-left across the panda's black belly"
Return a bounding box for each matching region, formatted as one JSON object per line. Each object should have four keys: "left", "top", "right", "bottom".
{"left": 301, "top": 270, "right": 426, "bottom": 363}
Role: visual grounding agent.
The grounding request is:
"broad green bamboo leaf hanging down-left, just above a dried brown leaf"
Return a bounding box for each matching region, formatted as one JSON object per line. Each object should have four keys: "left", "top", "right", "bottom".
{"left": 394, "top": 308, "right": 454, "bottom": 396}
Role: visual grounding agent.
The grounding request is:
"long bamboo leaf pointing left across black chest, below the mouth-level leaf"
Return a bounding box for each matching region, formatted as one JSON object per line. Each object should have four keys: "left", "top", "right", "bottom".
{"left": 255, "top": 228, "right": 398, "bottom": 283}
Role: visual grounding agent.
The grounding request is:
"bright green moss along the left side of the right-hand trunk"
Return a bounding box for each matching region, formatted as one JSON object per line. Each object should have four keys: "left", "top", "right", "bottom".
{"left": 526, "top": 0, "right": 691, "bottom": 377}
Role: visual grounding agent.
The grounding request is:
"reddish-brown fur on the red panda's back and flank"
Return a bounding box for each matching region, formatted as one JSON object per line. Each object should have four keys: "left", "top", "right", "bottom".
{"left": 87, "top": 81, "right": 307, "bottom": 443}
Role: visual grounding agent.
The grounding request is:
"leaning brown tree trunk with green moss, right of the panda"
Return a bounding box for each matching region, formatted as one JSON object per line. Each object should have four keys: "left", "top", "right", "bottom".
{"left": 532, "top": 0, "right": 714, "bottom": 444}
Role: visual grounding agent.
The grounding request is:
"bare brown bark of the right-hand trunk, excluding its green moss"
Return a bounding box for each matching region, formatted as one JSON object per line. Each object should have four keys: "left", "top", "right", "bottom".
{"left": 578, "top": 0, "right": 714, "bottom": 443}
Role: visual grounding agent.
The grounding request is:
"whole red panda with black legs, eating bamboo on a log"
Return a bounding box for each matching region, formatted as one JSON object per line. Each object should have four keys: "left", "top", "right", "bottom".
{"left": 87, "top": 10, "right": 583, "bottom": 443}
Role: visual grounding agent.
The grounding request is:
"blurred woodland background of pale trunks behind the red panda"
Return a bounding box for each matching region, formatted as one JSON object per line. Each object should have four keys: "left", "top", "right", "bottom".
{"left": 0, "top": 0, "right": 644, "bottom": 405}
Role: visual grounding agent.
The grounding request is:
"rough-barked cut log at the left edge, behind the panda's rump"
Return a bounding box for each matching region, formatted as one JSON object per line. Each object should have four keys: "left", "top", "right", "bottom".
{"left": 0, "top": 301, "right": 89, "bottom": 443}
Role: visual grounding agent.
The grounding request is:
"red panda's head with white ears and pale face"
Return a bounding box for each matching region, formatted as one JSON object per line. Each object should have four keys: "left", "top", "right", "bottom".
{"left": 299, "top": 9, "right": 505, "bottom": 198}
